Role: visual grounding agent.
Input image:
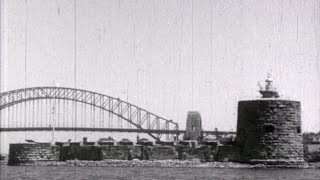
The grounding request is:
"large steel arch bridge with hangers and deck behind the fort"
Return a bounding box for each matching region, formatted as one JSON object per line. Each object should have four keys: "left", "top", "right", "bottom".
{"left": 0, "top": 87, "right": 183, "bottom": 141}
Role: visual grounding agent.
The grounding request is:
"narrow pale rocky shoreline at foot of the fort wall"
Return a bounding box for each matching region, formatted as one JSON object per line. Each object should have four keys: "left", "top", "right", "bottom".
{"left": 9, "top": 160, "right": 320, "bottom": 169}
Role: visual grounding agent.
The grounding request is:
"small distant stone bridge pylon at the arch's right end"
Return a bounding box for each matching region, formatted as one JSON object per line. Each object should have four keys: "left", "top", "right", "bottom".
{"left": 184, "top": 111, "right": 202, "bottom": 140}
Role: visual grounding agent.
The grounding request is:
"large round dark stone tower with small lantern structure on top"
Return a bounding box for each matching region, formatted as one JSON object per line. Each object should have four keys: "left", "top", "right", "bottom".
{"left": 236, "top": 76, "right": 304, "bottom": 167}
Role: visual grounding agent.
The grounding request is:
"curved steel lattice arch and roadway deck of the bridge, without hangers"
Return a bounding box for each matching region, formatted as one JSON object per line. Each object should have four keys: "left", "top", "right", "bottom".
{"left": 0, "top": 87, "right": 179, "bottom": 141}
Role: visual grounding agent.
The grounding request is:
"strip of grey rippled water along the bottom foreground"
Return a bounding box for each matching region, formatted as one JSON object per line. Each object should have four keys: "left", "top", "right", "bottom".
{"left": 1, "top": 163, "right": 320, "bottom": 180}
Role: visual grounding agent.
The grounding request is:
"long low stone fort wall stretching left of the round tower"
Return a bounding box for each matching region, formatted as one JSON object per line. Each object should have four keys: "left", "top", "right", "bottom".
{"left": 8, "top": 143, "right": 223, "bottom": 165}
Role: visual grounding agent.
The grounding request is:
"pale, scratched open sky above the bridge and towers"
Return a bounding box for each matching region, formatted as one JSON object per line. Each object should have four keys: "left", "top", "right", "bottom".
{"left": 0, "top": 0, "right": 320, "bottom": 132}
